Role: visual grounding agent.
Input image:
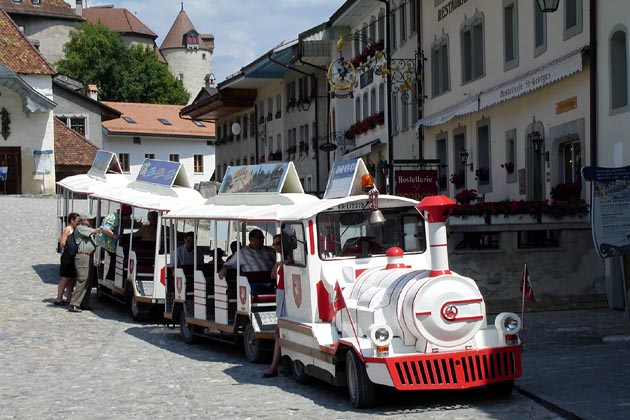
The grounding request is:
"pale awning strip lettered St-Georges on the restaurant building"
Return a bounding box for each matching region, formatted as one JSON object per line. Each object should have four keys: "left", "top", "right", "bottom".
{"left": 479, "top": 48, "right": 583, "bottom": 110}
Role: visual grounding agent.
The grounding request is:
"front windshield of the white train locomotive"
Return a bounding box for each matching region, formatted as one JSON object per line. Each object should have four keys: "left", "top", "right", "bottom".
{"left": 317, "top": 207, "right": 426, "bottom": 259}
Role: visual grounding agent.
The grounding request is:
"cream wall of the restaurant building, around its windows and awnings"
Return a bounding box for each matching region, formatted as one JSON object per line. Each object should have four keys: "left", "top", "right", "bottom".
{"left": 422, "top": 0, "right": 590, "bottom": 201}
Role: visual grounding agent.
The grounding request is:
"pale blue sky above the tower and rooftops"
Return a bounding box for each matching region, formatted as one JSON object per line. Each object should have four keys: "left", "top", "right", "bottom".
{"left": 86, "top": 0, "right": 344, "bottom": 83}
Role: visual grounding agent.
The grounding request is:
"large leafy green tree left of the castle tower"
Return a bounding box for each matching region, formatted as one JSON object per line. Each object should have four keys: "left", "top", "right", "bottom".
{"left": 57, "top": 22, "right": 189, "bottom": 105}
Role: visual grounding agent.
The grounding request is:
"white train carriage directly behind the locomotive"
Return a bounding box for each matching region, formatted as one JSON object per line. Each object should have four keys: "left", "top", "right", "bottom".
{"left": 164, "top": 162, "right": 319, "bottom": 362}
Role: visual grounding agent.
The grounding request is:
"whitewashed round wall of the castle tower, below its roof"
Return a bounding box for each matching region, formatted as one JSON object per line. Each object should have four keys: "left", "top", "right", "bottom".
{"left": 162, "top": 48, "right": 212, "bottom": 104}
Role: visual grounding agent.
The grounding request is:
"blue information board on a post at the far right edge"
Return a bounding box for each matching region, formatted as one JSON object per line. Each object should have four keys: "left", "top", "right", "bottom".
{"left": 582, "top": 166, "right": 630, "bottom": 258}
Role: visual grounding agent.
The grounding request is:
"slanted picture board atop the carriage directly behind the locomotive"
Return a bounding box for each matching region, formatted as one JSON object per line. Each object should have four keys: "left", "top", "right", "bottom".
{"left": 219, "top": 163, "right": 289, "bottom": 194}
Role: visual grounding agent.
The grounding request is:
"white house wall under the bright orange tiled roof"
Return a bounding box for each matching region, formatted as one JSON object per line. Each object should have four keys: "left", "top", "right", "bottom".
{"left": 103, "top": 133, "right": 215, "bottom": 184}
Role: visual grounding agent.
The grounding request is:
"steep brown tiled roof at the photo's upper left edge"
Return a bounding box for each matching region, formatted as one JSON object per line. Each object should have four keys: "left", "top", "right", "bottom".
{"left": 0, "top": 10, "right": 55, "bottom": 75}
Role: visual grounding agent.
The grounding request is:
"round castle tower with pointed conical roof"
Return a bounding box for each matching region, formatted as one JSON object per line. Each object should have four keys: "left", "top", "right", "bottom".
{"left": 160, "top": 2, "right": 214, "bottom": 104}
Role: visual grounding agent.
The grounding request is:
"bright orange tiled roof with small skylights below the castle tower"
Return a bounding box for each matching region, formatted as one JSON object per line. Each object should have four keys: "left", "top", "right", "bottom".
{"left": 103, "top": 102, "right": 214, "bottom": 139}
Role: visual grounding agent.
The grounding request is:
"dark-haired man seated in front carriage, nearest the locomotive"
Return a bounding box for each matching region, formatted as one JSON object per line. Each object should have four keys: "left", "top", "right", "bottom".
{"left": 219, "top": 229, "right": 276, "bottom": 294}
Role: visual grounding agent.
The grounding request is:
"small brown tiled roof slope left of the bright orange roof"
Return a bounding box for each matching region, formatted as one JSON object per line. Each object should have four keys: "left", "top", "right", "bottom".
{"left": 55, "top": 118, "right": 98, "bottom": 167}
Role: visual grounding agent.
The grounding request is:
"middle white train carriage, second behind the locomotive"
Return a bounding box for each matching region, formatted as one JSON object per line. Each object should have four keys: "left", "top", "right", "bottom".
{"left": 92, "top": 159, "right": 204, "bottom": 320}
